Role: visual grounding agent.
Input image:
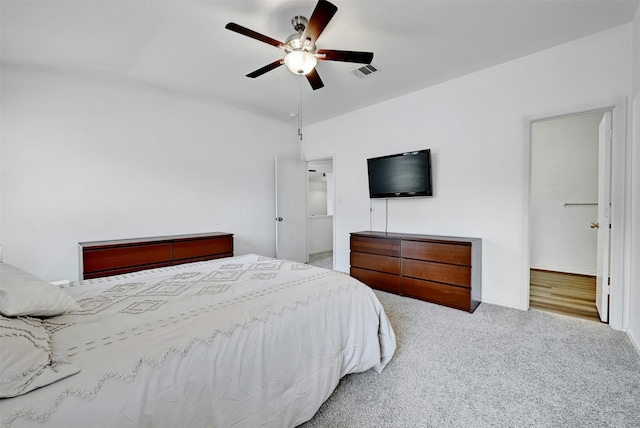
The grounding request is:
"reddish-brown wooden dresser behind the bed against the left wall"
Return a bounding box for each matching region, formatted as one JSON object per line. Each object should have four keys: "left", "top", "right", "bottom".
{"left": 78, "top": 232, "right": 233, "bottom": 279}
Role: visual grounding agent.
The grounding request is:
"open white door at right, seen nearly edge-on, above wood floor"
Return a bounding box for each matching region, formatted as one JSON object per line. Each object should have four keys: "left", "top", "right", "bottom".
{"left": 591, "top": 111, "right": 612, "bottom": 322}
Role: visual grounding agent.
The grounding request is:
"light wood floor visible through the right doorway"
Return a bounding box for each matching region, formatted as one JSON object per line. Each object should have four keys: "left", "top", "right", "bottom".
{"left": 529, "top": 269, "right": 600, "bottom": 322}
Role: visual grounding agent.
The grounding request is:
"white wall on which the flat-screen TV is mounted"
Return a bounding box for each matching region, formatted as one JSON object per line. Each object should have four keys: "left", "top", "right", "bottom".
{"left": 304, "top": 24, "right": 631, "bottom": 309}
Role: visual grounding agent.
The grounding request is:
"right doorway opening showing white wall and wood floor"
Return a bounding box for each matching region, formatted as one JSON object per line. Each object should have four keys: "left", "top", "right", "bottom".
{"left": 529, "top": 109, "right": 611, "bottom": 322}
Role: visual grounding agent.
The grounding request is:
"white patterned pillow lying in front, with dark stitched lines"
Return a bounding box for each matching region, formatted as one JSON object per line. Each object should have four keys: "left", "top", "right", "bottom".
{"left": 0, "top": 316, "right": 80, "bottom": 398}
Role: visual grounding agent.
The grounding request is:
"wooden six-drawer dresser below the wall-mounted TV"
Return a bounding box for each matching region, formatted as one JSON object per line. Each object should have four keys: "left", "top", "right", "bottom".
{"left": 351, "top": 231, "right": 482, "bottom": 312}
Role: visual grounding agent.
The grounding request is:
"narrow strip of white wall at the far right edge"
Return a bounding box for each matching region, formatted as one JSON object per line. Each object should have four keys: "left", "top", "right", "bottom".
{"left": 628, "top": 7, "right": 640, "bottom": 352}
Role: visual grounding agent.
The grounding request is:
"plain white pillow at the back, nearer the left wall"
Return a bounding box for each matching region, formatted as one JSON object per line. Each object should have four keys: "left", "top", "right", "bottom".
{"left": 0, "top": 263, "right": 82, "bottom": 317}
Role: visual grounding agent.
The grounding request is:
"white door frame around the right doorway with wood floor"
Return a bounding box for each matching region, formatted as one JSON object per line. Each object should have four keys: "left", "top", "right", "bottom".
{"left": 520, "top": 97, "right": 629, "bottom": 330}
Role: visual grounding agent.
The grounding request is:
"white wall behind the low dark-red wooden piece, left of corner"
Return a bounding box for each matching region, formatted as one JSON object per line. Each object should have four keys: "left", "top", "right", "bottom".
{"left": 0, "top": 66, "right": 300, "bottom": 280}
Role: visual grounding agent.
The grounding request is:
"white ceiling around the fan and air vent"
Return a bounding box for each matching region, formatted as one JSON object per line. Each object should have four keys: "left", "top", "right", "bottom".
{"left": 0, "top": 0, "right": 638, "bottom": 124}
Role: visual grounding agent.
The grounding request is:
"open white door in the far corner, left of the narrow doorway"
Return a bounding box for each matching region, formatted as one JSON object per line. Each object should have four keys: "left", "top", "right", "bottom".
{"left": 275, "top": 156, "right": 307, "bottom": 263}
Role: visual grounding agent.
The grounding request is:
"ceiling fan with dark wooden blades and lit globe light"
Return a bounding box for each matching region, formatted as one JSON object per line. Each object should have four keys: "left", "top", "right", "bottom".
{"left": 225, "top": 0, "right": 373, "bottom": 90}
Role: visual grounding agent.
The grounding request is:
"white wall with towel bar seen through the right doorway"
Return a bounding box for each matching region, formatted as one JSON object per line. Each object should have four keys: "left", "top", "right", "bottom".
{"left": 531, "top": 112, "right": 603, "bottom": 276}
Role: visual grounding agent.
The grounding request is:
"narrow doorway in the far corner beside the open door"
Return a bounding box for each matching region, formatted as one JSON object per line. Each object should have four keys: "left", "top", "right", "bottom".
{"left": 307, "top": 157, "right": 335, "bottom": 269}
